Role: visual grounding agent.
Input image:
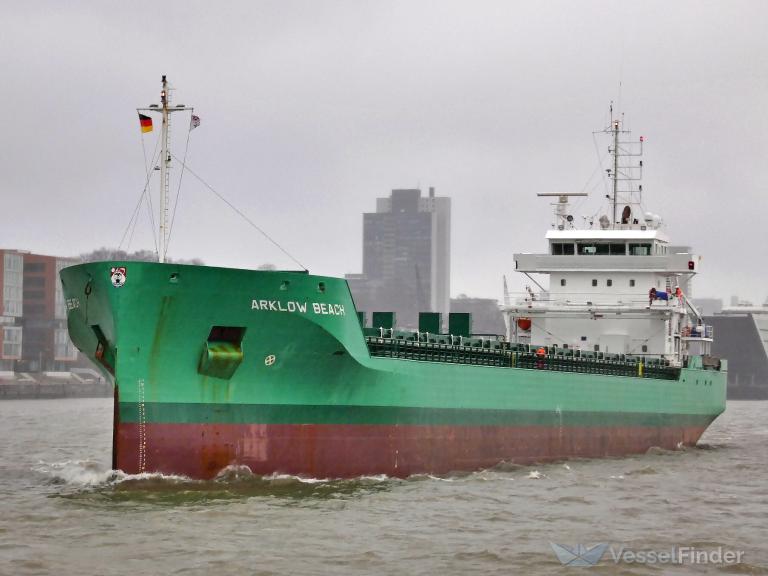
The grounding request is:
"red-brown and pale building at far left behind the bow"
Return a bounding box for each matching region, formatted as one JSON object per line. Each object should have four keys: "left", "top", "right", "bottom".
{"left": 0, "top": 250, "right": 78, "bottom": 373}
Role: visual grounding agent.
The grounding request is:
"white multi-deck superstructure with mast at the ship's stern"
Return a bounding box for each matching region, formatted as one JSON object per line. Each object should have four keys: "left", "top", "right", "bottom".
{"left": 505, "top": 110, "right": 712, "bottom": 365}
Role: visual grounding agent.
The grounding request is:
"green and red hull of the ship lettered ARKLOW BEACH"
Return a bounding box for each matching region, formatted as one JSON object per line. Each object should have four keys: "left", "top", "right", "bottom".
{"left": 61, "top": 262, "right": 726, "bottom": 478}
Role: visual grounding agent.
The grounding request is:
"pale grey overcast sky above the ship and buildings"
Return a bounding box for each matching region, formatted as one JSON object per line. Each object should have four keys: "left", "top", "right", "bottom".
{"left": 0, "top": 0, "right": 768, "bottom": 302}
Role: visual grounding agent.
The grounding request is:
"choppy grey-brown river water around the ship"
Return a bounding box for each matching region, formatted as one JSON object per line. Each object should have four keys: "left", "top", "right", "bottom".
{"left": 0, "top": 399, "right": 768, "bottom": 575}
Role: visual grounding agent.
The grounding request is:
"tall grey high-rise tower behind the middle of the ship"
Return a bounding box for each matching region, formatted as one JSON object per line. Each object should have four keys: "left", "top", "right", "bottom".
{"left": 346, "top": 188, "right": 451, "bottom": 327}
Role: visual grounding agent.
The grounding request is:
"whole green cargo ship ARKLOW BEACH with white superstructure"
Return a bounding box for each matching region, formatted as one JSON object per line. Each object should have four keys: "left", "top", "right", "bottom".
{"left": 61, "top": 77, "right": 727, "bottom": 479}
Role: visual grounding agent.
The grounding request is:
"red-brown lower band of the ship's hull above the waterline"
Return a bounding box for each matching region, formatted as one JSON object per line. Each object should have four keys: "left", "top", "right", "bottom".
{"left": 114, "top": 423, "right": 705, "bottom": 479}
